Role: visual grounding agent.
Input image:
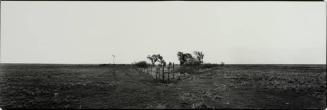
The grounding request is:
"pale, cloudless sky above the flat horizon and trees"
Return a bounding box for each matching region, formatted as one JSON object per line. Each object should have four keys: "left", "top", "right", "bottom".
{"left": 0, "top": 1, "right": 326, "bottom": 64}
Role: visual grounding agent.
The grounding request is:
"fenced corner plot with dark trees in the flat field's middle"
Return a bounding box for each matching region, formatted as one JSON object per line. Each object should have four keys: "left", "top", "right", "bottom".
{"left": 135, "top": 51, "right": 228, "bottom": 82}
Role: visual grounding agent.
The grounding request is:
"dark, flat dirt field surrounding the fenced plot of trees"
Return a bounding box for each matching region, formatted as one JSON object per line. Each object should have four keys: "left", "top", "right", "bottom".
{"left": 0, "top": 64, "right": 326, "bottom": 109}
